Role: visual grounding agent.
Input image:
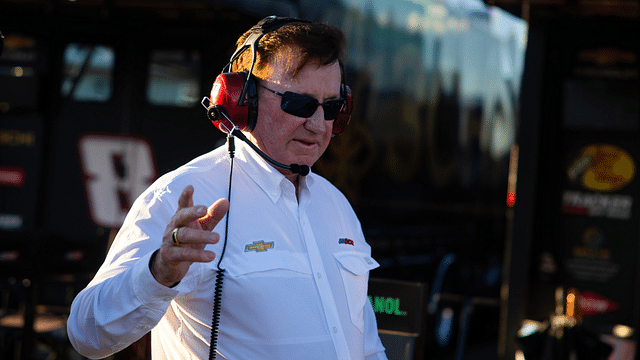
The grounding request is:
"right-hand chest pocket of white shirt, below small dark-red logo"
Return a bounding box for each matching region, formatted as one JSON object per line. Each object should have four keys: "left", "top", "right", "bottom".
{"left": 333, "top": 252, "right": 380, "bottom": 331}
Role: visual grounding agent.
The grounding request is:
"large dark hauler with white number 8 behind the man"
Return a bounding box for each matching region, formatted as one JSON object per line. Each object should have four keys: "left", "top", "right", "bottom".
{"left": 0, "top": 0, "right": 527, "bottom": 358}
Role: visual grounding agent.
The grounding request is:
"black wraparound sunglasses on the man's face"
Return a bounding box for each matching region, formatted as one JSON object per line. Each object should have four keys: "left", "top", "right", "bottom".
{"left": 258, "top": 84, "right": 345, "bottom": 120}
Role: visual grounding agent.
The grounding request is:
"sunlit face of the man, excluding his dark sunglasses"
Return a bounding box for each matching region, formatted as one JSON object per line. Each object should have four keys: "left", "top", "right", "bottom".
{"left": 251, "top": 51, "right": 341, "bottom": 178}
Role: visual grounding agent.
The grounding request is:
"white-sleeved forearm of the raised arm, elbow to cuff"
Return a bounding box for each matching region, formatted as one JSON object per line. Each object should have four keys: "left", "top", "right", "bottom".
{"left": 67, "top": 250, "right": 178, "bottom": 358}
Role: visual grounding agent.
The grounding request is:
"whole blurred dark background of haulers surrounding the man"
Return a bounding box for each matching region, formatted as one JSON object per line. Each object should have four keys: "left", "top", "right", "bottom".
{"left": 0, "top": 0, "right": 640, "bottom": 360}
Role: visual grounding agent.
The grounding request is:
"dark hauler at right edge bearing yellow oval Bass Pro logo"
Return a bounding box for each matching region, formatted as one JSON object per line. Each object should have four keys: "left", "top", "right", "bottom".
{"left": 501, "top": 1, "right": 640, "bottom": 359}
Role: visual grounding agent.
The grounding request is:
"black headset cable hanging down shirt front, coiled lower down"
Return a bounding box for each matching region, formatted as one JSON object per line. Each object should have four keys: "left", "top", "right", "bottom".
{"left": 209, "top": 134, "right": 236, "bottom": 360}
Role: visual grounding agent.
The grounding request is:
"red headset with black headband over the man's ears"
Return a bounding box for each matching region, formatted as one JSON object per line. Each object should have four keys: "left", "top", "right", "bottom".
{"left": 203, "top": 16, "right": 353, "bottom": 135}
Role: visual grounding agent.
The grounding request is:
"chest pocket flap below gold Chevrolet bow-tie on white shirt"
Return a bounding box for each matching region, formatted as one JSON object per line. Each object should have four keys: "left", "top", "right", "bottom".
{"left": 222, "top": 249, "right": 311, "bottom": 277}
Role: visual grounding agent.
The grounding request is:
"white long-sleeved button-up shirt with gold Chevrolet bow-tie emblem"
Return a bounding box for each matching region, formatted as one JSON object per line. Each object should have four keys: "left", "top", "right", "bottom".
{"left": 68, "top": 141, "right": 386, "bottom": 360}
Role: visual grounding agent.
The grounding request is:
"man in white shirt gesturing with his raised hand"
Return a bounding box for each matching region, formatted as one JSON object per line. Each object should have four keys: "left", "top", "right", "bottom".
{"left": 68, "top": 15, "right": 386, "bottom": 360}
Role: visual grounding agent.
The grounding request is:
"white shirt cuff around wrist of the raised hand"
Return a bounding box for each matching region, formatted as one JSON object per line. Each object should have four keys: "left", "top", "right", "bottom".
{"left": 131, "top": 253, "right": 180, "bottom": 311}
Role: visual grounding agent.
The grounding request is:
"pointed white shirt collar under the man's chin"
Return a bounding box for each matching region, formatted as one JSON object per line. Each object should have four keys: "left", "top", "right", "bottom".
{"left": 235, "top": 140, "right": 314, "bottom": 203}
